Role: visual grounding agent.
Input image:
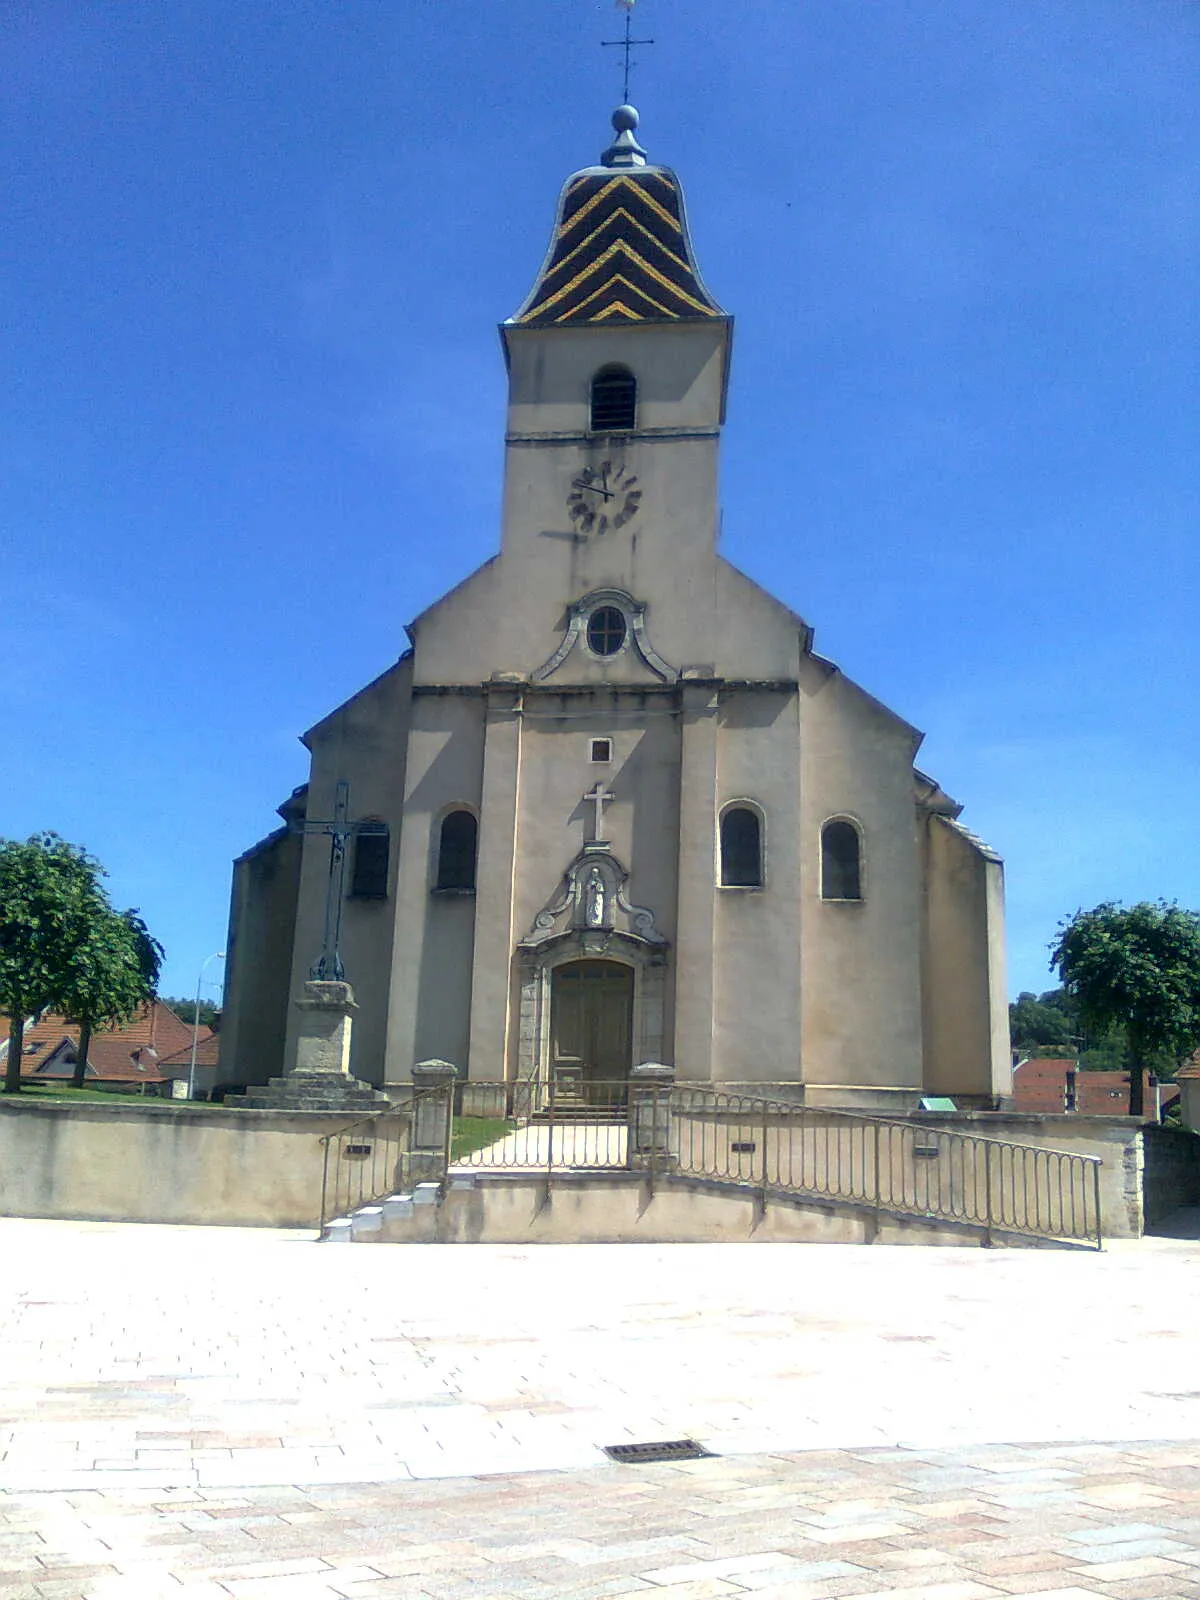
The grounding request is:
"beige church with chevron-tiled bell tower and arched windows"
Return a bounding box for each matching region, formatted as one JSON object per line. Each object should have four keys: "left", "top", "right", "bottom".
{"left": 222, "top": 106, "right": 1011, "bottom": 1114}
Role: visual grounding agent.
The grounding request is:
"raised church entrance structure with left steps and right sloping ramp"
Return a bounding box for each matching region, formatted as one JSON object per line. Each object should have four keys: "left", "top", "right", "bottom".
{"left": 322, "top": 1085, "right": 1102, "bottom": 1250}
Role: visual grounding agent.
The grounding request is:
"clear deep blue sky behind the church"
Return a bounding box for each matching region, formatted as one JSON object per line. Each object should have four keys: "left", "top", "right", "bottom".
{"left": 0, "top": 0, "right": 1200, "bottom": 994}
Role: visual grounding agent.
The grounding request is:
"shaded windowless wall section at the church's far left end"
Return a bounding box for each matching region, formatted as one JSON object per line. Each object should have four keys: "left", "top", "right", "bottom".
{"left": 219, "top": 832, "right": 301, "bottom": 1085}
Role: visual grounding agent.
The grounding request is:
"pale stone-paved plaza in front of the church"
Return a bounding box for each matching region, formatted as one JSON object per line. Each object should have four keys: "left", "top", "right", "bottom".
{"left": 0, "top": 1219, "right": 1200, "bottom": 1600}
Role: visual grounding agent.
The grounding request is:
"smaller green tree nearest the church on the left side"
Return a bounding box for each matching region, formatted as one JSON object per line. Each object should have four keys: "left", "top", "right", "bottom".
{"left": 62, "top": 901, "right": 163, "bottom": 1090}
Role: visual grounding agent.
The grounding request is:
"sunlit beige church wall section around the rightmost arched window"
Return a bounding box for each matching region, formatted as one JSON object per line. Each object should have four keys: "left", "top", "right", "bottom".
{"left": 800, "top": 658, "right": 922, "bottom": 1109}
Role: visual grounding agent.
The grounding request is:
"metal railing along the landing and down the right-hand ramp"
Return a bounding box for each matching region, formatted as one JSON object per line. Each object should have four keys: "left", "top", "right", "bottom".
{"left": 450, "top": 1080, "right": 1102, "bottom": 1248}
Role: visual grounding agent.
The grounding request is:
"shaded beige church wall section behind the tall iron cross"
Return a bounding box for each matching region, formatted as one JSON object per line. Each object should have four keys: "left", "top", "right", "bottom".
{"left": 285, "top": 659, "right": 411, "bottom": 1083}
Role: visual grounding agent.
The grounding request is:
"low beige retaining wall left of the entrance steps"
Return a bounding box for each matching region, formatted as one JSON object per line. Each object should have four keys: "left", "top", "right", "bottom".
{"left": 0, "top": 1101, "right": 347, "bottom": 1227}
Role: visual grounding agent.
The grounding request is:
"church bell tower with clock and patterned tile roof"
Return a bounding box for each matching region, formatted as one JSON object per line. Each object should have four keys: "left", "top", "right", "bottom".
{"left": 501, "top": 106, "right": 733, "bottom": 624}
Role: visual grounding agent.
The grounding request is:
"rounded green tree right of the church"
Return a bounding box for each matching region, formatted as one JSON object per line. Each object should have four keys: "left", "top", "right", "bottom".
{"left": 1050, "top": 901, "right": 1200, "bottom": 1117}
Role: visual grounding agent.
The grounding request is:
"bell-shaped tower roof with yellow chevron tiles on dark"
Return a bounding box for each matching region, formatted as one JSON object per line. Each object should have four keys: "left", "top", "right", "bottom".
{"left": 509, "top": 106, "right": 725, "bottom": 328}
